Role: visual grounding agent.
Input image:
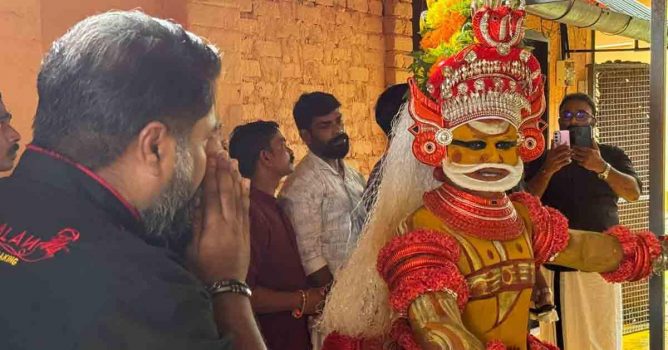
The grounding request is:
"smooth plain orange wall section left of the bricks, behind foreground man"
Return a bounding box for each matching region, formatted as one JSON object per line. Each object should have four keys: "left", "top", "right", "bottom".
{"left": 0, "top": 0, "right": 186, "bottom": 177}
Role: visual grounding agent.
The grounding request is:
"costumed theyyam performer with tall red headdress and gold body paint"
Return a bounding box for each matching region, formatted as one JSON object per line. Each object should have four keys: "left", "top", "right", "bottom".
{"left": 322, "top": 0, "right": 664, "bottom": 350}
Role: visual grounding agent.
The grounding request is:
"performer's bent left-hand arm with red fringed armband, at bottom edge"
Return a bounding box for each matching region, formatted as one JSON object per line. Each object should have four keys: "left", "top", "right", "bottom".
{"left": 377, "top": 229, "right": 503, "bottom": 350}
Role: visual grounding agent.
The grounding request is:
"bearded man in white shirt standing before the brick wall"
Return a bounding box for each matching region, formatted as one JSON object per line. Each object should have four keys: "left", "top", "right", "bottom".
{"left": 279, "top": 92, "right": 366, "bottom": 287}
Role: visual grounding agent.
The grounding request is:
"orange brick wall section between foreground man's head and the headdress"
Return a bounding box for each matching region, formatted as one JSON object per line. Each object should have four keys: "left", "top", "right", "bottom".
{"left": 187, "top": 0, "right": 412, "bottom": 173}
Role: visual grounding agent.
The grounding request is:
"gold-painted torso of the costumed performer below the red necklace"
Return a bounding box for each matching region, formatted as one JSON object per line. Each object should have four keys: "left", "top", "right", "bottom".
{"left": 410, "top": 208, "right": 536, "bottom": 349}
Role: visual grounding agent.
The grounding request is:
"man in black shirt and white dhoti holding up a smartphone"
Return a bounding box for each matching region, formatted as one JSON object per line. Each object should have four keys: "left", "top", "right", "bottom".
{"left": 526, "top": 93, "right": 642, "bottom": 350}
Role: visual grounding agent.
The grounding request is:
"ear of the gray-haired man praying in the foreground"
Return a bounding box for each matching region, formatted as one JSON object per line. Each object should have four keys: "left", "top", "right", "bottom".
{"left": 136, "top": 121, "right": 176, "bottom": 176}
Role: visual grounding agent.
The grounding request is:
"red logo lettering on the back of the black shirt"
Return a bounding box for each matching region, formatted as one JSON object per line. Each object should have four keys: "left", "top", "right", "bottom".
{"left": 0, "top": 224, "right": 80, "bottom": 266}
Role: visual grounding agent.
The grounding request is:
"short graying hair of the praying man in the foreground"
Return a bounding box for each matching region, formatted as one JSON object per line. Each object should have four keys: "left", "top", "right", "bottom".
{"left": 33, "top": 11, "right": 220, "bottom": 169}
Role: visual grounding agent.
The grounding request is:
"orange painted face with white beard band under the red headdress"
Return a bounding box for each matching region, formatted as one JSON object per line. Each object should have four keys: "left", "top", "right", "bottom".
{"left": 443, "top": 121, "right": 524, "bottom": 192}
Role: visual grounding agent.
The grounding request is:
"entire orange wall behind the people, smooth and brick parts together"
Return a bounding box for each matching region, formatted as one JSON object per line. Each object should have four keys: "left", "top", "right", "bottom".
{"left": 0, "top": 0, "right": 591, "bottom": 178}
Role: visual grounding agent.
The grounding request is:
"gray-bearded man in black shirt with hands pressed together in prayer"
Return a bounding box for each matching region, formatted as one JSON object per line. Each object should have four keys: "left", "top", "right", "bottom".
{"left": 0, "top": 12, "right": 265, "bottom": 350}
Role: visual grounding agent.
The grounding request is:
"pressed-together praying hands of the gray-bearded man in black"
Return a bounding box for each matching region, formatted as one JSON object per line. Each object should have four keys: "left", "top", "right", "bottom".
{"left": 188, "top": 143, "right": 250, "bottom": 283}
